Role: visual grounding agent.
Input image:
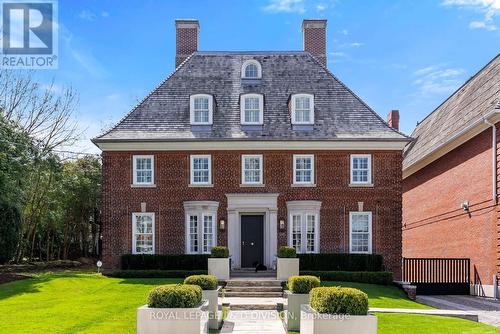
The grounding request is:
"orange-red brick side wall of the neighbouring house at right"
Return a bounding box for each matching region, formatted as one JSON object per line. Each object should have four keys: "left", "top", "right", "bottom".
{"left": 403, "top": 128, "right": 499, "bottom": 292}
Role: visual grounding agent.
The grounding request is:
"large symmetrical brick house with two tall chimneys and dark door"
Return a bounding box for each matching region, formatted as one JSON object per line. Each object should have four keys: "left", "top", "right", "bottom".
{"left": 94, "top": 20, "right": 409, "bottom": 277}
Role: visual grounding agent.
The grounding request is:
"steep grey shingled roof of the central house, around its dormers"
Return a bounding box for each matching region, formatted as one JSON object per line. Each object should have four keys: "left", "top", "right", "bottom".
{"left": 94, "top": 51, "right": 409, "bottom": 143}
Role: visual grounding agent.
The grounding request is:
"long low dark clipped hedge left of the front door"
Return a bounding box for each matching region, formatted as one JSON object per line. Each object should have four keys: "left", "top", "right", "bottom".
{"left": 121, "top": 254, "right": 209, "bottom": 270}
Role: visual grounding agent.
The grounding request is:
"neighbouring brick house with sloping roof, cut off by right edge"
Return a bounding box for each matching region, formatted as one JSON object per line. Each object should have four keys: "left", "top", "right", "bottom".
{"left": 403, "top": 56, "right": 500, "bottom": 296}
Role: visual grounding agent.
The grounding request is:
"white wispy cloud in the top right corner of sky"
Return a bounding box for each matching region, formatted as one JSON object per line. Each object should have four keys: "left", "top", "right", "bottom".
{"left": 442, "top": 0, "right": 500, "bottom": 31}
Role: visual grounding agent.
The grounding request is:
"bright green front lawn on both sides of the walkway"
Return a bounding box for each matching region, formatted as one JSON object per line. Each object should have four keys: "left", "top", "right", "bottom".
{"left": 0, "top": 272, "right": 498, "bottom": 334}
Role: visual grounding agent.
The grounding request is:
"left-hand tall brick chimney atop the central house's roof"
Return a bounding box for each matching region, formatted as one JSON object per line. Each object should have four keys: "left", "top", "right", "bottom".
{"left": 175, "top": 19, "right": 200, "bottom": 68}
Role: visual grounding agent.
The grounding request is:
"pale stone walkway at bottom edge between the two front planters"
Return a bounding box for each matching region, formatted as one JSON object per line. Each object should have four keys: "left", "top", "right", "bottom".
{"left": 220, "top": 310, "right": 286, "bottom": 334}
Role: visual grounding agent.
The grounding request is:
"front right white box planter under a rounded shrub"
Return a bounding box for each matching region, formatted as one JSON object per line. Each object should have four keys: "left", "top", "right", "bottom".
{"left": 300, "top": 305, "right": 377, "bottom": 334}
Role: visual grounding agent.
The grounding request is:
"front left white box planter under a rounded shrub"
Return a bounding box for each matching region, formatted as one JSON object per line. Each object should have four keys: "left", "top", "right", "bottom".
{"left": 137, "top": 300, "right": 208, "bottom": 334}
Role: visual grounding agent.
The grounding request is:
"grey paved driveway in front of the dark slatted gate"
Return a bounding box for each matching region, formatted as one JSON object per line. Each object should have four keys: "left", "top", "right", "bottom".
{"left": 417, "top": 295, "right": 500, "bottom": 327}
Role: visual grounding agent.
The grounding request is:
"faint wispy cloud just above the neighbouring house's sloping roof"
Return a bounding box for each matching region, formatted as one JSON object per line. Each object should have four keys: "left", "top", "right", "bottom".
{"left": 413, "top": 65, "right": 465, "bottom": 96}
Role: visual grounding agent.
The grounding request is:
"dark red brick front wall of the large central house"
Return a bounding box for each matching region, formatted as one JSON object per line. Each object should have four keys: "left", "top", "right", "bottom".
{"left": 102, "top": 151, "right": 402, "bottom": 279}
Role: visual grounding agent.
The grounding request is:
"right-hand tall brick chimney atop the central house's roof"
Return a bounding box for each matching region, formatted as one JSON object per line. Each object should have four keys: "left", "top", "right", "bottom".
{"left": 302, "top": 19, "right": 326, "bottom": 66}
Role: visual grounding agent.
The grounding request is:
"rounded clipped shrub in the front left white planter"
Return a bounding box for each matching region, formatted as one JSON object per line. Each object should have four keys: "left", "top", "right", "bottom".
{"left": 148, "top": 284, "right": 201, "bottom": 308}
